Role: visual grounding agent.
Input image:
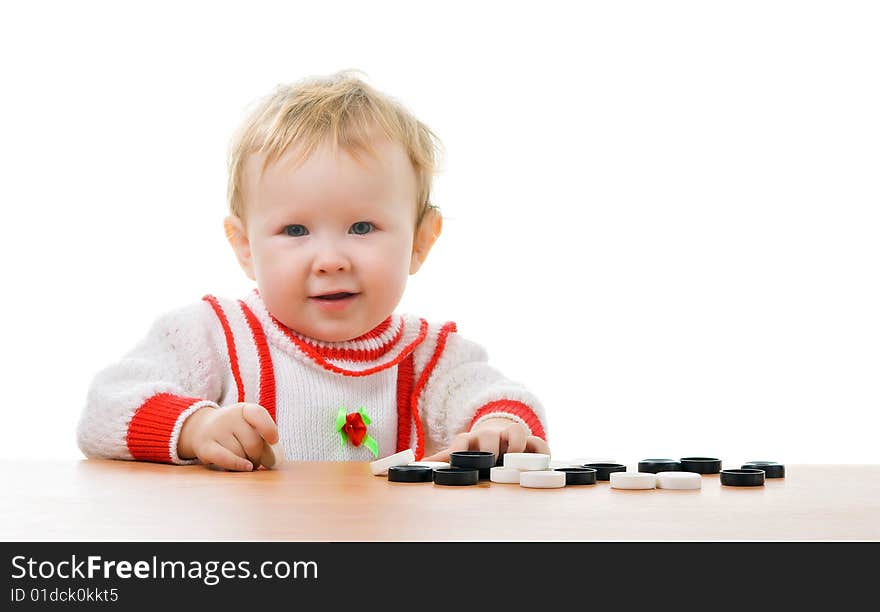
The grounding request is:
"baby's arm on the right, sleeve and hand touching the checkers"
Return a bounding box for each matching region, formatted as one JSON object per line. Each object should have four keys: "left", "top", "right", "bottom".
{"left": 420, "top": 332, "right": 550, "bottom": 460}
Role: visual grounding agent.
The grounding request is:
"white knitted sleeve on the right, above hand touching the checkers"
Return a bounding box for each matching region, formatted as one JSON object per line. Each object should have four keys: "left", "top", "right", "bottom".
{"left": 421, "top": 324, "right": 547, "bottom": 448}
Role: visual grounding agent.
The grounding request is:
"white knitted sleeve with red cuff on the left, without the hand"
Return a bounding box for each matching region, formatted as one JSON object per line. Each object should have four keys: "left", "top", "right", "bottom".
{"left": 77, "top": 302, "right": 223, "bottom": 465}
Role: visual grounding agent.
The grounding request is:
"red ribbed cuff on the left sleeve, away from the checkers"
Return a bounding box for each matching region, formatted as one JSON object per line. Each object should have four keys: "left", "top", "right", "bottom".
{"left": 126, "top": 393, "right": 204, "bottom": 463}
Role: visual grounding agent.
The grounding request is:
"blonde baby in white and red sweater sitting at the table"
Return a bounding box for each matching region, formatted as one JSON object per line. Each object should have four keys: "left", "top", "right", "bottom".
{"left": 78, "top": 72, "right": 549, "bottom": 470}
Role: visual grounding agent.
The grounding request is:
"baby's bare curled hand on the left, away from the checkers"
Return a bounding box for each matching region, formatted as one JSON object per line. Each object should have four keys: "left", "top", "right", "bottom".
{"left": 177, "top": 403, "right": 278, "bottom": 471}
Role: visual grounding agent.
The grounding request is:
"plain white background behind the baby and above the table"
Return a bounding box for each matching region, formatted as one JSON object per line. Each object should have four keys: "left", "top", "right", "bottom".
{"left": 0, "top": 0, "right": 880, "bottom": 464}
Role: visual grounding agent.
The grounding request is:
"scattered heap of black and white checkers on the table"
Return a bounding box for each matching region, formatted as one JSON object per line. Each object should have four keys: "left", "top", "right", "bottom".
{"left": 370, "top": 449, "right": 785, "bottom": 489}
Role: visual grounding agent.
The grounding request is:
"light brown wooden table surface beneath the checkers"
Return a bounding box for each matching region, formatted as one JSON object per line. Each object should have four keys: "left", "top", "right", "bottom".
{"left": 0, "top": 459, "right": 880, "bottom": 541}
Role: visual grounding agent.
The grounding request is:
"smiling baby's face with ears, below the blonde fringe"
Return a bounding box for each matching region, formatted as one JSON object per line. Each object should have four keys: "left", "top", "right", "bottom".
{"left": 226, "top": 134, "right": 440, "bottom": 342}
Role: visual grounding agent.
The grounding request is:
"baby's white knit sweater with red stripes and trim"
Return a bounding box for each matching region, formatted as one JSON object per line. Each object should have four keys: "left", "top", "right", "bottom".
{"left": 77, "top": 291, "right": 546, "bottom": 464}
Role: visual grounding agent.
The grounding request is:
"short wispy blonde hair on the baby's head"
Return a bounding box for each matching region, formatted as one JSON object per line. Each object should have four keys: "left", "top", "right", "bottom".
{"left": 227, "top": 70, "right": 442, "bottom": 228}
